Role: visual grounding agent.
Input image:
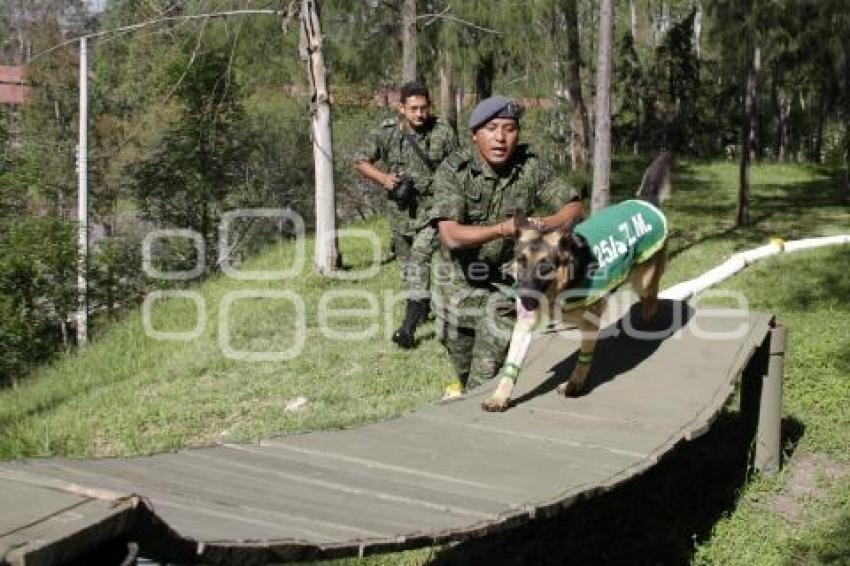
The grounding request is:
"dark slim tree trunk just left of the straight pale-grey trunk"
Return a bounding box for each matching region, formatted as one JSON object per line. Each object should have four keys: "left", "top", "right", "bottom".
{"left": 563, "top": 0, "right": 590, "bottom": 171}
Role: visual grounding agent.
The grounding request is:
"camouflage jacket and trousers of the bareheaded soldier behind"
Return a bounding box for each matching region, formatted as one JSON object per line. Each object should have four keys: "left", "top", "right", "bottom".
{"left": 354, "top": 118, "right": 457, "bottom": 291}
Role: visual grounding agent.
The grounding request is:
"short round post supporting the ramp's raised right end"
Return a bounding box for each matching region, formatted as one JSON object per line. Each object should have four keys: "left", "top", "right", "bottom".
{"left": 754, "top": 325, "right": 788, "bottom": 474}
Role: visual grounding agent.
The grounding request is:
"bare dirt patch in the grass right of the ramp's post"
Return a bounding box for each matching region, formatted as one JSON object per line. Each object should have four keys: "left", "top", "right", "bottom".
{"left": 764, "top": 453, "right": 850, "bottom": 524}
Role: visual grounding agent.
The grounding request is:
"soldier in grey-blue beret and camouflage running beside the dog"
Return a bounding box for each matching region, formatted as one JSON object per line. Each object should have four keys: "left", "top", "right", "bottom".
{"left": 428, "top": 96, "right": 582, "bottom": 398}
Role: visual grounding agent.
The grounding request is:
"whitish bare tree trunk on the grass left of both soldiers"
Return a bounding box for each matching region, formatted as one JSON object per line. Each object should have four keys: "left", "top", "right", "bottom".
{"left": 301, "top": 0, "right": 339, "bottom": 275}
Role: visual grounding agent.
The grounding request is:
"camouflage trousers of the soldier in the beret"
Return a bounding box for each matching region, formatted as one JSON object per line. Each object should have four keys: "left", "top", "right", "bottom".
{"left": 435, "top": 291, "right": 516, "bottom": 389}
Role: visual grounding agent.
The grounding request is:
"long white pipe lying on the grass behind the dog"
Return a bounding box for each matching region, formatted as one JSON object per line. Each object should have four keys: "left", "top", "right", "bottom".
{"left": 659, "top": 234, "right": 850, "bottom": 301}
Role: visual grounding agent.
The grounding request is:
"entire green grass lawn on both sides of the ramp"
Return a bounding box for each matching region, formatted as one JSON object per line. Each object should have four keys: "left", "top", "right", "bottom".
{"left": 0, "top": 159, "right": 850, "bottom": 565}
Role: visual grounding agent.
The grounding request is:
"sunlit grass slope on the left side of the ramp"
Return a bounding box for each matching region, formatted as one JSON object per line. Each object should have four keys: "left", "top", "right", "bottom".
{"left": 0, "top": 215, "right": 451, "bottom": 458}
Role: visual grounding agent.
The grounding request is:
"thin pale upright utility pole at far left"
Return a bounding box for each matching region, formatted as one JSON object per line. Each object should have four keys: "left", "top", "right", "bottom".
{"left": 77, "top": 37, "right": 89, "bottom": 346}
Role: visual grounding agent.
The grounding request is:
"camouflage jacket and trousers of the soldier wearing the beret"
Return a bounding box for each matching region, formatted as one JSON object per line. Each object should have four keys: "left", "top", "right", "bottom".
{"left": 428, "top": 144, "right": 579, "bottom": 387}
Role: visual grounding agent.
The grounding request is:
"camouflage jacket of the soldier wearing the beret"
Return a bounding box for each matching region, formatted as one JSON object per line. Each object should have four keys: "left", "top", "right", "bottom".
{"left": 427, "top": 144, "right": 579, "bottom": 326}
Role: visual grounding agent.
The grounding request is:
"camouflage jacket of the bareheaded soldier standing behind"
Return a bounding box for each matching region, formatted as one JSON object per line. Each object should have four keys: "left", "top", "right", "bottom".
{"left": 354, "top": 118, "right": 457, "bottom": 235}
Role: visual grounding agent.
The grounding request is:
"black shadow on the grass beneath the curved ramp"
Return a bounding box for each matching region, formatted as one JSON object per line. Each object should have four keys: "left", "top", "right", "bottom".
{"left": 432, "top": 412, "right": 800, "bottom": 566}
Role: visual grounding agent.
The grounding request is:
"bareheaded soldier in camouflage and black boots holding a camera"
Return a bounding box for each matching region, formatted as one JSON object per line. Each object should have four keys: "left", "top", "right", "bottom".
{"left": 354, "top": 82, "right": 457, "bottom": 348}
